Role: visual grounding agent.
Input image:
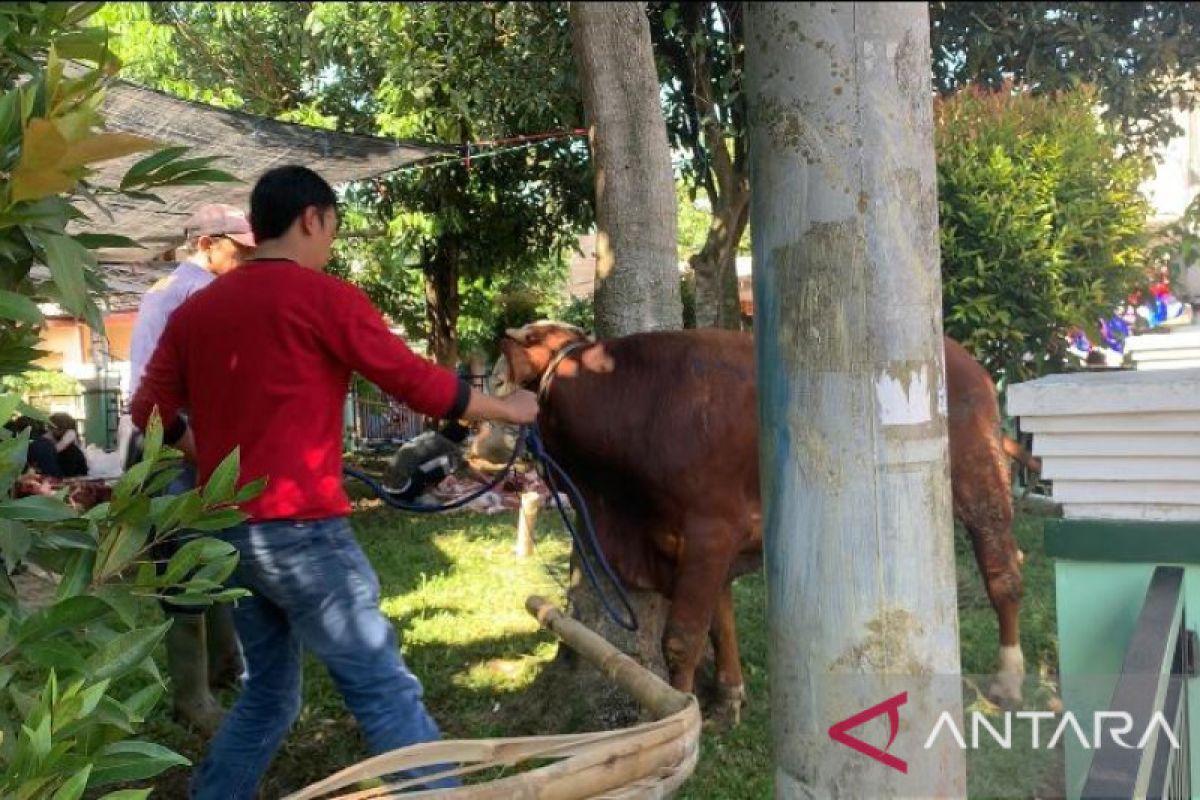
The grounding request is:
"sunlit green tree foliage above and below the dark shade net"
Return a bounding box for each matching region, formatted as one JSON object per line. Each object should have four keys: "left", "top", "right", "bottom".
{"left": 99, "top": 2, "right": 592, "bottom": 363}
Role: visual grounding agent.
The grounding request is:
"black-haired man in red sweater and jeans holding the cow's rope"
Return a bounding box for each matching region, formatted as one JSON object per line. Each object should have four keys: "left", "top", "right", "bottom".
{"left": 132, "top": 166, "right": 538, "bottom": 800}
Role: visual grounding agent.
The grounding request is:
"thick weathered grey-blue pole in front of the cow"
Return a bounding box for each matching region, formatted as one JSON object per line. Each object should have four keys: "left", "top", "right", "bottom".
{"left": 744, "top": 2, "right": 966, "bottom": 798}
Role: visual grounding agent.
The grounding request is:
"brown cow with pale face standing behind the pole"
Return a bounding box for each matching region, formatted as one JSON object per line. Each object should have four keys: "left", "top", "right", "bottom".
{"left": 497, "top": 321, "right": 1025, "bottom": 720}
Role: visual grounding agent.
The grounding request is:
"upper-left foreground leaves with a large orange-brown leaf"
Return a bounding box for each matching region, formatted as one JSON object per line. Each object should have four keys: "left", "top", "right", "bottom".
{"left": 0, "top": 2, "right": 233, "bottom": 377}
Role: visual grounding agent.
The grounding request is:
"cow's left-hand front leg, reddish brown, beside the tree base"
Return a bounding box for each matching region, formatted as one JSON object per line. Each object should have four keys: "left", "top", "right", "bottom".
{"left": 662, "top": 519, "right": 736, "bottom": 692}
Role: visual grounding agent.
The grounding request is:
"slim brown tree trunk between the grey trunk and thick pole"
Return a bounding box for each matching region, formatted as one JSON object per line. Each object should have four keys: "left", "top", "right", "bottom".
{"left": 689, "top": 191, "right": 750, "bottom": 330}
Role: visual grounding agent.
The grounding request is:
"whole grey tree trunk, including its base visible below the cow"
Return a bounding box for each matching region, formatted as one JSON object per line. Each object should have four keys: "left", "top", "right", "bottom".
{"left": 537, "top": 2, "right": 683, "bottom": 727}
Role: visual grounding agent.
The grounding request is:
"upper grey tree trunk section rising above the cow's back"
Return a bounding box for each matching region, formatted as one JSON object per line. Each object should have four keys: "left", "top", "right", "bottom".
{"left": 570, "top": 2, "right": 683, "bottom": 336}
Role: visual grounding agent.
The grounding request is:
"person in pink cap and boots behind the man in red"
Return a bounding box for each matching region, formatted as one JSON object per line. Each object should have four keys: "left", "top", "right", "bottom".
{"left": 126, "top": 203, "right": 254, "bottom": 735}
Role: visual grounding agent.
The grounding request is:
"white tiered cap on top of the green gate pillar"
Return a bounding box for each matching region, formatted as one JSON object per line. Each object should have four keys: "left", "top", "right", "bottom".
{"left": 1007, "top": 369, "right": 1200, "bottom": 521}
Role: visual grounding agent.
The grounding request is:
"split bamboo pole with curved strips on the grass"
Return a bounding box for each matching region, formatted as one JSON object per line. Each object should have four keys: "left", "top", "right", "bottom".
{"left": 284, "top": 596, "right": 701, "bottom": 800}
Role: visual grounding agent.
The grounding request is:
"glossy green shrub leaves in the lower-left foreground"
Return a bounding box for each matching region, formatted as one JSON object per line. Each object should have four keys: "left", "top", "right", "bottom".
{"left": 0, "top": 410, "right": 262, "bottom": 798}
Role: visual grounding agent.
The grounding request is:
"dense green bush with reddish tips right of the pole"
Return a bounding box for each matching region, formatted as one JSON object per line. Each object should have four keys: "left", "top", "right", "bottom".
{"left": 936, "top": 90, "right": 1148, "bottom": 380}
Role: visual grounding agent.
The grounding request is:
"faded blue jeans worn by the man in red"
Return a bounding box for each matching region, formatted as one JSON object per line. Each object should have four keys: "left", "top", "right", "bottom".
{"left": 192, "top": 517, "right": 458, "bottom": 800}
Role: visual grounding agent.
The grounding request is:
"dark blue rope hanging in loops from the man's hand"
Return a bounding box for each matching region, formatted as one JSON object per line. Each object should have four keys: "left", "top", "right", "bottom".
{"left": 342, "top": 425, "right": 637, "bottom": 631}
